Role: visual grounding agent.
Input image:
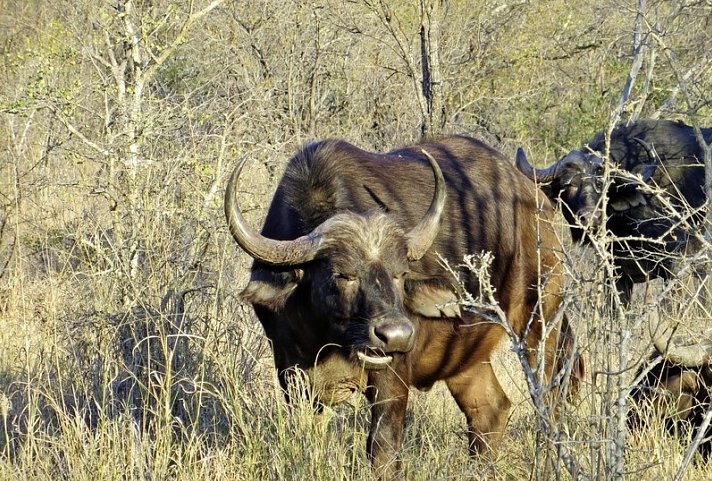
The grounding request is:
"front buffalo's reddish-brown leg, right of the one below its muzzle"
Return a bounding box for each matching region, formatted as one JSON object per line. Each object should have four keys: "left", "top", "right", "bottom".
{"left": 447, "top": 362, "right": 512, "bottom": 455}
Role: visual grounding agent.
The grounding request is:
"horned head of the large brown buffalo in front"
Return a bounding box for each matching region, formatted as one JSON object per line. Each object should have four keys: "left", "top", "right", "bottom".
{"left": 225, "top": 150, "right": 445, "bottom": 371}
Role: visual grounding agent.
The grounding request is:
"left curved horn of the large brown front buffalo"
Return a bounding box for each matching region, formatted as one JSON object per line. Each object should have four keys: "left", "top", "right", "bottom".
{"left": 225, "top": 159, "right": 321, "bottom": 266}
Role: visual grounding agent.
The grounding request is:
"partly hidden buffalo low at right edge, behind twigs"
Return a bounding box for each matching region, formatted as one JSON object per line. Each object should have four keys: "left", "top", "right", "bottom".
{"left": 628, "top": 333, "right": 712, "bottom": 459}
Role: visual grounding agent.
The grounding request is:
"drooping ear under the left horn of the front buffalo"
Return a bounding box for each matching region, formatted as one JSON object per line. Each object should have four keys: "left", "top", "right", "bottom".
{"left": 240, "top": 269, "right": 304, "bottom": 311}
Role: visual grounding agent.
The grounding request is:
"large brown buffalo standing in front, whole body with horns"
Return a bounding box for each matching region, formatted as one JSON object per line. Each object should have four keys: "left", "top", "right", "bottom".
{"left": 225, "top": 136, "right": 583, "bottom": 478}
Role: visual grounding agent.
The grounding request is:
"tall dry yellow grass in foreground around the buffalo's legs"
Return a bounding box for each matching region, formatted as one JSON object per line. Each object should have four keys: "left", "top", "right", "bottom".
{"left": 0, "top": 200, "right": 708, "bottom": 480}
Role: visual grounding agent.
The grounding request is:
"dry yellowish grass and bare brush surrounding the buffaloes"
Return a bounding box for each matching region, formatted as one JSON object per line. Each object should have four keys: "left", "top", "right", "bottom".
{"left": 0, "top": 0, "right": 712, "bottom": 480}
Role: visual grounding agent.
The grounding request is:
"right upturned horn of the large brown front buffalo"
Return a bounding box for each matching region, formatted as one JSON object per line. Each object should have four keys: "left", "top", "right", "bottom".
{"left": 406, "top": 149, "right": 446, "bottom": 261}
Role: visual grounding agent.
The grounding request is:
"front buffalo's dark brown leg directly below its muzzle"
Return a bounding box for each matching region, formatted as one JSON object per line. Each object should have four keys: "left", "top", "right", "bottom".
{"left": 366, "top": 371, "right": 408, "bottom": 480}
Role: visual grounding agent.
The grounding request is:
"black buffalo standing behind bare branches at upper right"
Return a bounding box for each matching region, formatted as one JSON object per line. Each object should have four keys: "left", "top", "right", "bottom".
{"left": 516, "top": 120, "right": 712, "bottom": 303}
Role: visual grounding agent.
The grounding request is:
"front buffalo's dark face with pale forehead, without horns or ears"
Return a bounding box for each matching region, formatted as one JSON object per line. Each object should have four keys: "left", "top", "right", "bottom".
{"left": 304, "top": 213, "right": 415, "bottom": 368}
